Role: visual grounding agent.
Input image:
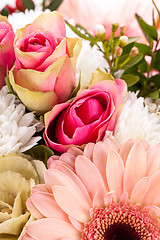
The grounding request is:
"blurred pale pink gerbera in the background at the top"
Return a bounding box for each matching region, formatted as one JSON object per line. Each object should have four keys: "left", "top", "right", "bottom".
{"left": 58, "top": 0, "right": 156, "bottom": 40}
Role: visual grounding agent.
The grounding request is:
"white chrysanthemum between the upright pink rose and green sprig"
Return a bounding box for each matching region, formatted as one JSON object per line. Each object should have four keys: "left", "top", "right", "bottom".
{"left": 66, "top": 20, "right": 108, "bottom": 88}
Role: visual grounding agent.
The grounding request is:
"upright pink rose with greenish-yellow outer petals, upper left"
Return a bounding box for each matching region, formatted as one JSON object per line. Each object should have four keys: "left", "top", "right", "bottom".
{"left": 9, "top": 11, "right": 80, "bottom": 115}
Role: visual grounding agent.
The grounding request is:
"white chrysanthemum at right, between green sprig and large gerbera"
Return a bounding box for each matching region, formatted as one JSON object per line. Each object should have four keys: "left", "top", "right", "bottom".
{"left": 114, "top": 93, "right": 160, "bottom": 145}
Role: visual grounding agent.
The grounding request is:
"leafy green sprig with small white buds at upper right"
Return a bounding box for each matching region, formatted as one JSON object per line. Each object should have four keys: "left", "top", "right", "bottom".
{"left": 66, "top": 0, "right": 160, "bottom": 99}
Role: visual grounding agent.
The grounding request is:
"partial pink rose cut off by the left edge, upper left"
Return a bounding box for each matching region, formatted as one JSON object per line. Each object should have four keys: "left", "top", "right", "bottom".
{"left": 0, "top": 15, "right": 15, "bottom": 89}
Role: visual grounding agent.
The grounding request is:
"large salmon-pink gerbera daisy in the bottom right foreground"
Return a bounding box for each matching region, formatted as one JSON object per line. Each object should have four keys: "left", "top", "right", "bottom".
{"left": 22, "top": 138, "right": 160, "bottom": 240}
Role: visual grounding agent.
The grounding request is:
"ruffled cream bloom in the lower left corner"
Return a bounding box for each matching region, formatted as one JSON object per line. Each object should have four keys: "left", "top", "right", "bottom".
{"left": 0, "top": 154, "right": 46, "bottom": 240}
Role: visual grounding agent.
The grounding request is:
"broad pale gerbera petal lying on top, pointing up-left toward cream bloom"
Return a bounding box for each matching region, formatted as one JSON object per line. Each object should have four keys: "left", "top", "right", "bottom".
{"left": 52, "top": 186, "right": 90, "bottom": 223}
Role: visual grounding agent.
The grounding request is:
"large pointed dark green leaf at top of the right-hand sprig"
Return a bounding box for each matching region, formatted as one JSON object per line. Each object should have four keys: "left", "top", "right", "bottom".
{"left": 136, "top": 14, "right": 158, "bottom": 42}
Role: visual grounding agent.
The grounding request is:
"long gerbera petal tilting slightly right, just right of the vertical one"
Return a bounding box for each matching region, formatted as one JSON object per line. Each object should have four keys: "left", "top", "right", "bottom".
{"left": 123, "top": 142, "right": 146, "bottom": 195}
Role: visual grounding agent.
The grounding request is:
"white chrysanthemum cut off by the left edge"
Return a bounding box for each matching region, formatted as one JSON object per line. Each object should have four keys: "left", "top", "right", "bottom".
{"left": 0, "top": 86, "right": 41, "bottom": 155}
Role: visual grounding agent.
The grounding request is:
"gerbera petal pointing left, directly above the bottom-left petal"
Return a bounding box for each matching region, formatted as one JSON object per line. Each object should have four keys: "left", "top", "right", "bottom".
{"left": 30, "top": 193, "right": 67, "bottom": 221}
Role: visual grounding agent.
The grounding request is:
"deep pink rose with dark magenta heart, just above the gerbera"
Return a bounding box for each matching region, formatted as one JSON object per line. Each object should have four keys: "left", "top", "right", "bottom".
{"left": 44, "top": 79, "right": 126, "bottom": 153}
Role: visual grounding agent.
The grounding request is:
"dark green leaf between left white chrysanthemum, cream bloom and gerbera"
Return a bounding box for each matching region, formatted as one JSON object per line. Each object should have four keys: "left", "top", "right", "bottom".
{"left": 24, "top": 145, "right": 54, "bottom": 165}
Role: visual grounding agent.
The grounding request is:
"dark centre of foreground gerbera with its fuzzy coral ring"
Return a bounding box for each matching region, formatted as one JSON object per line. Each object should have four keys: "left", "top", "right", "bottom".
{"left": 82, "top": 203, "right": 160, "bottom": 240}
